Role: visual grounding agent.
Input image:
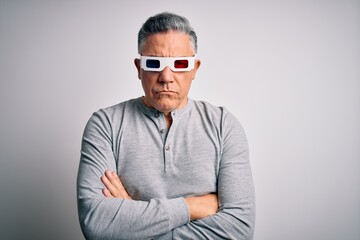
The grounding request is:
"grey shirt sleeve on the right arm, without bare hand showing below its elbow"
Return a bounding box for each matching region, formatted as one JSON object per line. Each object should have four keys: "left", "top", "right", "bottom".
{"left": 163, "top": 109, "right": 255, "bottom": 239}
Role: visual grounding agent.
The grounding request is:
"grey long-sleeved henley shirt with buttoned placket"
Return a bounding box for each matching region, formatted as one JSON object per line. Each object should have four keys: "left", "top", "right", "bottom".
{"left": 77, "top": 98, "right": 255, "bottom": 239}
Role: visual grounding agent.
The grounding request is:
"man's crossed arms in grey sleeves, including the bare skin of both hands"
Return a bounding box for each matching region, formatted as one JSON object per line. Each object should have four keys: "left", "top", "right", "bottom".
{"left": 77, "top": 109, "right": 255, "bottom": 239}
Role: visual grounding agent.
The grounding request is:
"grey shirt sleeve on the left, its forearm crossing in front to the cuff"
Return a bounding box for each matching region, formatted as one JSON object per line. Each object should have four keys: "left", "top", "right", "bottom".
{"left": 77, "top": 111, "right": 190, "bottom": 239}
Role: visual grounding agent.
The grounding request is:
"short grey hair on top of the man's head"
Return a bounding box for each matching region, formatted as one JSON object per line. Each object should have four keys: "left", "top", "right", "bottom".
{"left": 138, "top": 12, "right": 197, "bottom": 54}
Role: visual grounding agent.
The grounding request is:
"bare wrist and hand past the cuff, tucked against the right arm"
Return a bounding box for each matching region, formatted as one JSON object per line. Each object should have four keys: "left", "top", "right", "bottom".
{"left": 185, "top": 194, "right": 219, "bottom": 221}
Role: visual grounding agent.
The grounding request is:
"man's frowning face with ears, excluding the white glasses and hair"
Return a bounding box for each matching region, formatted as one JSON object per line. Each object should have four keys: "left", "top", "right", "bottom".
{"left": 135, "top": 31, "right": 200, "bottom": 114}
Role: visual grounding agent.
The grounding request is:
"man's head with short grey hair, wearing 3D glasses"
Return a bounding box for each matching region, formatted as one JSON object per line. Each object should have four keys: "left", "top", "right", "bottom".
{"left": 135, "top": 13, "right": 200, "bottom": 114}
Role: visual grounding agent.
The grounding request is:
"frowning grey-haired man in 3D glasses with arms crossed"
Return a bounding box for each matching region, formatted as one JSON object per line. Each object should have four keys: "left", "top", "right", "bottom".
{"left": 77, "top": 13, "right": 255, "bottom": 239}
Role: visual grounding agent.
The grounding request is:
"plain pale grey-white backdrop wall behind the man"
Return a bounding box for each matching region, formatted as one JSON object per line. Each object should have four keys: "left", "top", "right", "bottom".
{"left": 0, "top": 0, "right": 360, "bottom": 240}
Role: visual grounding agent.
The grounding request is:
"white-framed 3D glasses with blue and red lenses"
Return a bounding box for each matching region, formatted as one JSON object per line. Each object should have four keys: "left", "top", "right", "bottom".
{"left": 140, "top": 56, "right": 195, "bottom": 72}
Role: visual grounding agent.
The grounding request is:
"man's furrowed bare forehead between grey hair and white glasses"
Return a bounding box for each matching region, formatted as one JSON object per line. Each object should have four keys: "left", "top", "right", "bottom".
{"left": 141, "top": 31, "right": 195, "bottom": 57}
